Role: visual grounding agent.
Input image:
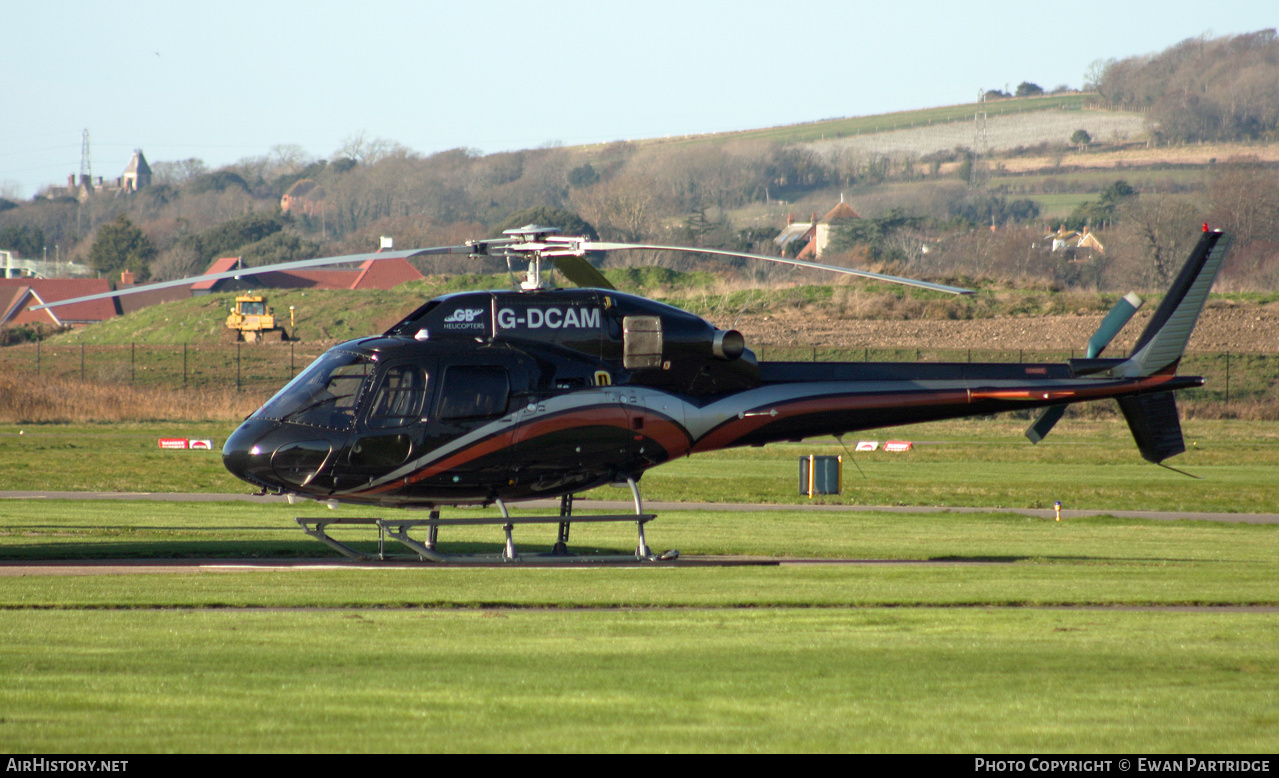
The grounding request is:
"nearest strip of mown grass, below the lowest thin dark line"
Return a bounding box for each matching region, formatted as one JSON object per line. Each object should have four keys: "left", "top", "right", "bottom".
{"left": 0, "top": 609, "right": 1279, "bottom": 752}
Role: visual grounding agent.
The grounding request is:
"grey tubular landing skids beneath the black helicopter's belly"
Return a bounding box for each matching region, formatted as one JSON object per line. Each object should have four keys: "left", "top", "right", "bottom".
{"left": 294, "top": 479, "right": 679, "bottom": 564}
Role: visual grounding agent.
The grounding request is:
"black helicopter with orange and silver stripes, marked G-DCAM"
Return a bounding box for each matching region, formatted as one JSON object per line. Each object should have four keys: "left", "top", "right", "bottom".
{"left": 37, "top": 225, "right": 1230, "bottom": 562}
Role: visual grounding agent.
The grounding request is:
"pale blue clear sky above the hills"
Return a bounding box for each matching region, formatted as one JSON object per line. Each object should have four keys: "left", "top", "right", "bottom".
{"left": 0, "top": 0, "right": 1279, "bottom": 197}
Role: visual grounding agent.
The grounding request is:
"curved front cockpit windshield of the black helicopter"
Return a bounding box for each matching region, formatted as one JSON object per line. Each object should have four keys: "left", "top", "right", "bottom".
{"left": 253, "top": 351, "right": 376, "bottom": 430}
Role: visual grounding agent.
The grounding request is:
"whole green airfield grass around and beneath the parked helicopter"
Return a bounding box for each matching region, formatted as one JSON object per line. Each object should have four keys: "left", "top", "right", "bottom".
{"left": 0, "top": 418, "right": 1279, "bottom": 754}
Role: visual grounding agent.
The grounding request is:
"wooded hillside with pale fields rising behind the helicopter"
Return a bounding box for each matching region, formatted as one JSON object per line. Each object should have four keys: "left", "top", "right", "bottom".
{"left": 0, "top": 28, "right": 1279, "bottom": 309}
